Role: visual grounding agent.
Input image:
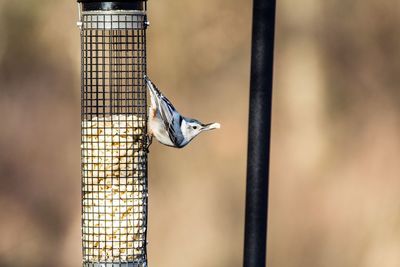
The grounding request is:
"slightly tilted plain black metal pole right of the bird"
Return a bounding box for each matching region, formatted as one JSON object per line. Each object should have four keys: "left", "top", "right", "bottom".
{"left": 243, "top": 0, "right": 276, "bottom": 267}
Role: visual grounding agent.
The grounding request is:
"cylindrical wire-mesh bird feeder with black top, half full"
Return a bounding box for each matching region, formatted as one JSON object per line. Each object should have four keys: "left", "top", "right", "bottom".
{"left": 78, "top": 0, "right": 148, "bottom": 267}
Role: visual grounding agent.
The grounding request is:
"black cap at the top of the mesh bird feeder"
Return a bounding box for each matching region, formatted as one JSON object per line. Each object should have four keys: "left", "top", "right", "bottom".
{"left": 78, "top": 0, "right": 146, "bottom": 11}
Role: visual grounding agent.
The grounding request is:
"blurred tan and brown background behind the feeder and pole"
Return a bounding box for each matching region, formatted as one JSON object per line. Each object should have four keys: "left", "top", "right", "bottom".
{"left": 0, "top": 0, "right": 400, "bottom": 267}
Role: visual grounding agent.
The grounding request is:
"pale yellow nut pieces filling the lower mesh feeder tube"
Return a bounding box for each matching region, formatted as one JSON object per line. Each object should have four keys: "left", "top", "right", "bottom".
{"left": 81, "top": 115, "right": 146, "bottom": 262}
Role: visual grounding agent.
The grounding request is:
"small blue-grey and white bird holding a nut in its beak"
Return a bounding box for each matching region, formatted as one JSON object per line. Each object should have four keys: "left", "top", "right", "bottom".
{"left": 144, "top": 75, "right": 221, "bottom": 148}
